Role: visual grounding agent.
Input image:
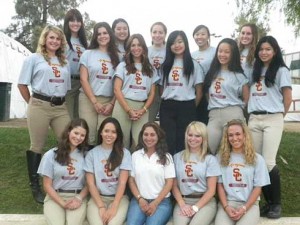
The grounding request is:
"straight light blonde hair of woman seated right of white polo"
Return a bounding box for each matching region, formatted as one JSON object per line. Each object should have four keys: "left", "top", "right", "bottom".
{"left": 182, "top": 121, "right": 209, "bottom": 162}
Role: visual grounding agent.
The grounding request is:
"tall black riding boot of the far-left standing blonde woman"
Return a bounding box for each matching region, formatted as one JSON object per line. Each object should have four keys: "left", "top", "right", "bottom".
{"left": 26, "top": 150, "right": 45, "bottom": 204}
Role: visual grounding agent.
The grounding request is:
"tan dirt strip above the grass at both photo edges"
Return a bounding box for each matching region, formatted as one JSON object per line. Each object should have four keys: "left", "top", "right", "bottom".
{"left": 0, "top": 119, "right": 300, "bottom": 132}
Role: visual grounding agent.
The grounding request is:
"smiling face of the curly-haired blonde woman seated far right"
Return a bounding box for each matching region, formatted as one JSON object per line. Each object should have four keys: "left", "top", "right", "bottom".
{"left": 227, "top": 125, "right": 245, "bottom": 152}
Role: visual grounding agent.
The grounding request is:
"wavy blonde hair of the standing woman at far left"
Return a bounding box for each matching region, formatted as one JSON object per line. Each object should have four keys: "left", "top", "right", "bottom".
{"left": 36, "top": 25, "right": 67, "bottom": 66}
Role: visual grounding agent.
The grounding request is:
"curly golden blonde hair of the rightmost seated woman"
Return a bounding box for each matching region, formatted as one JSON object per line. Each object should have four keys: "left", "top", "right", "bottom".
{"left": 219, "top": 119, "right": 256, "bottom": 166}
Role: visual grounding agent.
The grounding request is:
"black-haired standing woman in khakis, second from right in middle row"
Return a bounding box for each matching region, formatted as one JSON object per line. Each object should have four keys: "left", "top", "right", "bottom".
{"left": 204, "top": 38, "right": 249, "bottom": 154}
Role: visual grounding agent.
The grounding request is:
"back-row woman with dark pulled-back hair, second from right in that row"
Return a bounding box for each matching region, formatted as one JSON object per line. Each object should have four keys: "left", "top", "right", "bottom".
{"left": 192, "top": 25, "right": 216, "bottom": 124}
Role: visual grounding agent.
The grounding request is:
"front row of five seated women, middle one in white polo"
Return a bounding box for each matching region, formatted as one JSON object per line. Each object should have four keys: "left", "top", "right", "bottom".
{"left": 38, "top": 117, "right": 270, "bottom": 225}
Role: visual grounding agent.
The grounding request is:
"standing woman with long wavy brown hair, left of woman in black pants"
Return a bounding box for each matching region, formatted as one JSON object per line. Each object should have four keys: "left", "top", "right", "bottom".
{"left": 113, "top": 34, "right": 158, "bottom": 148}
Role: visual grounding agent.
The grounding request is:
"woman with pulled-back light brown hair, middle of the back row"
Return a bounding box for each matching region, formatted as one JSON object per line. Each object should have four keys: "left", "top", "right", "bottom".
{"left": 148, "top": 22, "right": 167, "bottom": 122}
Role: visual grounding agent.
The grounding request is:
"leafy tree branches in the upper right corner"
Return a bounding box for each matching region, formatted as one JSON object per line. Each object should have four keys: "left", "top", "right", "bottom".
{"left": 236, "top": 0, "right": 300, "bottom": 36}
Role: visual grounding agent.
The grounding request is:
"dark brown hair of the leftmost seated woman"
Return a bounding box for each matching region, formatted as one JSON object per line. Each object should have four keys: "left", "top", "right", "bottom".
{"left": 55, "top": 118, "right": 89, "bottom": 165}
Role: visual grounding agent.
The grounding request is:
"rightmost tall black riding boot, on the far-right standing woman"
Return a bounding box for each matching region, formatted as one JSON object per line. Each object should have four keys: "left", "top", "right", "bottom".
{"left": 267, "top": 166, "right": 281, "bottom": 219}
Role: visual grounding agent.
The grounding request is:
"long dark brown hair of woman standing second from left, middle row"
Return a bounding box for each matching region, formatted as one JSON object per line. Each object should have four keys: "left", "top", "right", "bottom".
{"left": 89, "top": 22, "right": 120, "bottom": 69}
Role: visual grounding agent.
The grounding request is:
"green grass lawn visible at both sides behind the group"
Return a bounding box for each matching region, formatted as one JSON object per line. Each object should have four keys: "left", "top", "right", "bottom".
{"left": 0, "top": 128, "right": 300, "bottom": 217}
